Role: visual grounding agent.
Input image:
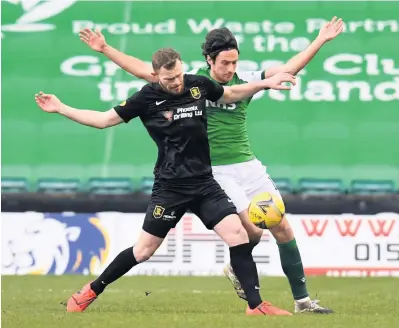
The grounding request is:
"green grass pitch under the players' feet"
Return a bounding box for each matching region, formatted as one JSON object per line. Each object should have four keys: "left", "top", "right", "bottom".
{"left": 1, "top": 276, "right": 399, "bottom": 328}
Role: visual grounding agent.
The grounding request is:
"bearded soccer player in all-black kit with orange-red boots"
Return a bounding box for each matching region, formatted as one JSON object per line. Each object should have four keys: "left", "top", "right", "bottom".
{"left": 35, "top": 49, "right": 295, "bottom": 315}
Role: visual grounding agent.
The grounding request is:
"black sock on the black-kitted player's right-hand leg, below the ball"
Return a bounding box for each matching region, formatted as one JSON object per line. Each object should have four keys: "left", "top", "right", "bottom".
{"left": 230, "top": 243, "right": 262, "bottom": 309}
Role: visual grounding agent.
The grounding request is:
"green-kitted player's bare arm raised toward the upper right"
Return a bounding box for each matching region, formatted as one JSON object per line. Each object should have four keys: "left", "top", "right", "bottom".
{"left": 265, "top": 16, "right": 343, "bottom": 78}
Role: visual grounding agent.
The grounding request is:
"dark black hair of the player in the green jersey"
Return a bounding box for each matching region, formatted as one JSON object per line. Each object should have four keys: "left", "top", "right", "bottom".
{"left": 201, "top": 27, "right": 240, "bottom": 66}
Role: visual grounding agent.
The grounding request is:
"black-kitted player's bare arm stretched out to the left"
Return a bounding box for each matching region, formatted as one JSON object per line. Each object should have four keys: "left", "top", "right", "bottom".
{"left": 35, "top": 92, "right": 123, "bottom": 129}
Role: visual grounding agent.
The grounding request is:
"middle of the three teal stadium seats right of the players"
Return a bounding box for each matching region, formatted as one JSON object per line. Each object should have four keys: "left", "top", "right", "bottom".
{"left": 298, "top": 178, "right": 344, "bottom": 196}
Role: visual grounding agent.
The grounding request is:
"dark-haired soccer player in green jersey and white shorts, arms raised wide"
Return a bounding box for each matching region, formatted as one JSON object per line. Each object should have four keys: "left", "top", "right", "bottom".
{"left": 80, "top": 17, "right": 343, "bottom": 314}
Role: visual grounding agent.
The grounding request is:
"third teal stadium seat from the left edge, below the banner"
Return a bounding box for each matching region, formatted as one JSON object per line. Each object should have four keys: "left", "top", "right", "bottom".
{"left": 87, "top": 178, "right": 134, "bottom": 195}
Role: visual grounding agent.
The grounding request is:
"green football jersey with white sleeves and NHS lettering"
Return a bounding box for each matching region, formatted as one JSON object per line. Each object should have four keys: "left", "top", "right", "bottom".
{"left": 189, "top": 67, "right": 264, "bottom": 165}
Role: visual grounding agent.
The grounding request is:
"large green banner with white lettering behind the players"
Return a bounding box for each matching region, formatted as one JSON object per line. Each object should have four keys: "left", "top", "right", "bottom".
{"left": 1, "top": 0, "right": 399, "bottom": 181}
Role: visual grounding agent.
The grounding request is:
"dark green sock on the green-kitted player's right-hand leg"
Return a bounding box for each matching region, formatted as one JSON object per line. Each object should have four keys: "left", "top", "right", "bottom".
{"left": 277, "top": 239, "right": 309, "bottom": 300}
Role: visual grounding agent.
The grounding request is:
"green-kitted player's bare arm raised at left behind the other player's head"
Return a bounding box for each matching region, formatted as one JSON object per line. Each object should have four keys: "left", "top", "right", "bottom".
{"left": 79, "top": 28, "right": 155, "bottom": 82}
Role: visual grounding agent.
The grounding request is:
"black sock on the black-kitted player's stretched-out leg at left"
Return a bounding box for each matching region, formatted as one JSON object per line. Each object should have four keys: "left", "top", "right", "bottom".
{"left": 90, "top": 247, "right": 138, "bottom": 296}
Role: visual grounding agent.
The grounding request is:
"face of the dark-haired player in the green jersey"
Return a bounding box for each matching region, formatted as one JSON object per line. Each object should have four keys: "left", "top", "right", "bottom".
{"left": 208, "top": 49, "right": 238, "bottom": 83}
